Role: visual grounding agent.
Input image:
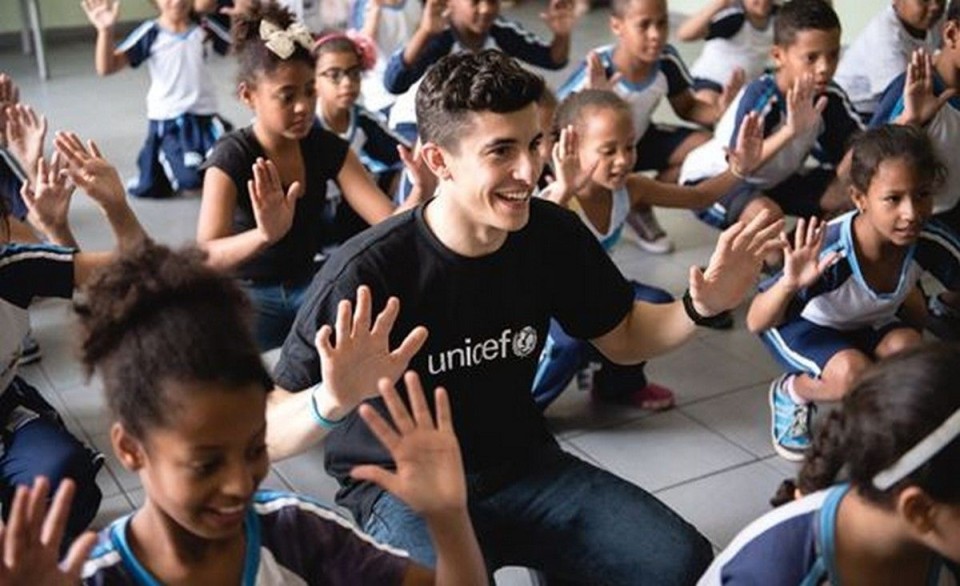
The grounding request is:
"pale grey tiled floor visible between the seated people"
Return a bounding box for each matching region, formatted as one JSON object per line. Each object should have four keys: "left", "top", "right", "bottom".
{"left": 0, "top": 3, "right": 804, "bottom": 584}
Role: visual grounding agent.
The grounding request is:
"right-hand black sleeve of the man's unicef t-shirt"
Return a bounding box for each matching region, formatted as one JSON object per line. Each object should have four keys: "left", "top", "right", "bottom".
{"left": 543, "top": 202, "right": 633, "bottom": 339}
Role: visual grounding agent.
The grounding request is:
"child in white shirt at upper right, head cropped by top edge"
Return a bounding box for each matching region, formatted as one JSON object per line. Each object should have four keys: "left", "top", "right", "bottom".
{"left": 677, "top": 0, "right": 777, "bottom": 107}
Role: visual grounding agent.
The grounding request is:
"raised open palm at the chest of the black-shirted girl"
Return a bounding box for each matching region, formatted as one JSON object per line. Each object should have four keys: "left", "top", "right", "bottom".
{"left": 247, "top": 157, "right": 303, "bottom": 244}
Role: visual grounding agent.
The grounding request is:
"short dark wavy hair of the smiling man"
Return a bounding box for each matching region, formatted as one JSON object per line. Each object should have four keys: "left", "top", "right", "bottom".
{"left": 417, "top": 49, "right": 544, "bottom": 149}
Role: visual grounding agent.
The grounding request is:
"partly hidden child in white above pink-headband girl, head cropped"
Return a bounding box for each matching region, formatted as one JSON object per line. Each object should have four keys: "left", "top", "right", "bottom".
{"left": 349, "top": 0, "right": 423, "bottom": 113}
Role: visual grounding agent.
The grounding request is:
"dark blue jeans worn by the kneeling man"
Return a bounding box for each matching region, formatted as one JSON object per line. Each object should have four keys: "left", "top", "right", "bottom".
{"left": 361, "top": 447, "right": 713, "bottom": 586}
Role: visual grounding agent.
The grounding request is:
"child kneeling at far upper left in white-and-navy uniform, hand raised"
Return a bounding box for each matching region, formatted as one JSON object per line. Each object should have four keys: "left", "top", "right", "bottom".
{"left": 82, "top": 0, "right": 229, "bottom": 198}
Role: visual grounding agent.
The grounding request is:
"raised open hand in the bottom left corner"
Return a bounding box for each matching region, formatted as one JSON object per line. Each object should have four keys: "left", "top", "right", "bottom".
{"left": 0, "top": 477, "right": 97, "bottom": 586}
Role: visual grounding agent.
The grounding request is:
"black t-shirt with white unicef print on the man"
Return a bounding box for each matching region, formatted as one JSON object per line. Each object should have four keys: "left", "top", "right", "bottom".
{"left": 275, "top": 199, "right": 633, "bottom": 515}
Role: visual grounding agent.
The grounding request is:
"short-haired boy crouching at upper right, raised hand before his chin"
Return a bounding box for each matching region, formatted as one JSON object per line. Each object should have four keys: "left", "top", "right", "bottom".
{"left": 680, "top": 0, "right": 863, "bottom": 237}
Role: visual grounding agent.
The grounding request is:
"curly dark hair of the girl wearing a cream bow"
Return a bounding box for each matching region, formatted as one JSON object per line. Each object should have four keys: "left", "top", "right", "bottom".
{"left": 231, "top": 0, "right": 316, "bottom": 84}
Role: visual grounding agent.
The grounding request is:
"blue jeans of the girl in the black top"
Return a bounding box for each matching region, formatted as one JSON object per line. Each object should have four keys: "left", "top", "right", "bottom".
{"left": 241, "top": 279, "right": 310, "bottom": 352}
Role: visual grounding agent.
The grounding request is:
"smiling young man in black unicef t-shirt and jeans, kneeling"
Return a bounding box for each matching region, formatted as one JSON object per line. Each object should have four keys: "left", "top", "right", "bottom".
{"left": 268, "top": 51, "right": 782, "bottom": 584}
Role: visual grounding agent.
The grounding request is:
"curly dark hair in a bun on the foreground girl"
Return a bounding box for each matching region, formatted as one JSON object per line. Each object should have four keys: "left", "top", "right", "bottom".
{"left": 75, "top": 241, "right": 273, "bottom": 438}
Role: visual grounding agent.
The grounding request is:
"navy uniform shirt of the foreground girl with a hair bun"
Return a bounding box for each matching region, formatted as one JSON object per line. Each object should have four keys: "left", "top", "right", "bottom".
{"left": 82, "top": 491, "right": 410, "bottom": 586}
